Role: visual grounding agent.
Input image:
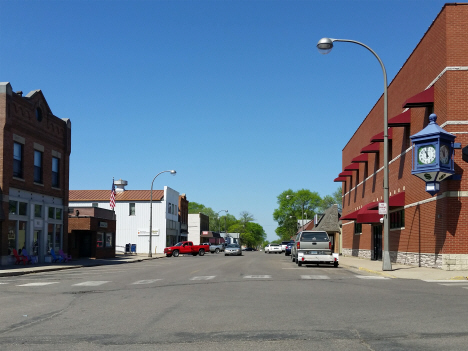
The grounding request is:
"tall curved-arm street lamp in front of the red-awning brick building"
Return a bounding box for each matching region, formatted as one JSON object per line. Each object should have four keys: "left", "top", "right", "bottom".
{"left": 317, "top": 38, "right": 392, "bottom": 271}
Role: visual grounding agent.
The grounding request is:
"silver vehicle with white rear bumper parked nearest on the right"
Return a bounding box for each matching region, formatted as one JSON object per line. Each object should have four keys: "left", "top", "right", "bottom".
{"left": 291, "top": 230, "right": 339, "bottom": 267}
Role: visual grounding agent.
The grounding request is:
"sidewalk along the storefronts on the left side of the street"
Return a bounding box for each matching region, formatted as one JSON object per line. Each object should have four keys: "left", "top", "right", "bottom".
{"left": 0, "top": 252, "right": 166, "bottom": 277}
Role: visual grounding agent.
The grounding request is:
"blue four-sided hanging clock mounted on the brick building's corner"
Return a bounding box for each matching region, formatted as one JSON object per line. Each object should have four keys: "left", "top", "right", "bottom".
{"left": 410, "top": 113, "right": 456, "bottom": 195}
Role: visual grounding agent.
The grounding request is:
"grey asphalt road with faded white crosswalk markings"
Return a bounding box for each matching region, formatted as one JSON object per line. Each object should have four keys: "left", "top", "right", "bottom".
{"left": 0, "top": 252, "right": 468, "bottom": 351}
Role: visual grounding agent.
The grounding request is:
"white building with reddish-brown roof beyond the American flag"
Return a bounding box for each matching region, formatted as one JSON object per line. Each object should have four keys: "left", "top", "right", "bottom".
{"left": 69, "top": 179, "right": 180, "bottom": 253}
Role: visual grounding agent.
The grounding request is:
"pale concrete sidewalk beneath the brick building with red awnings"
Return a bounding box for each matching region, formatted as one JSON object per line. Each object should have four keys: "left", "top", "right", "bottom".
{"left": 340, "top": 256, "right": 468, "bottom": 280}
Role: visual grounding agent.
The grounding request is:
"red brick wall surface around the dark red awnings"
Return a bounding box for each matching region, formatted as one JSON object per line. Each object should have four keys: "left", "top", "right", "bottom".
{"left": 342, "top": 5, "right": 468, "bottom": 260}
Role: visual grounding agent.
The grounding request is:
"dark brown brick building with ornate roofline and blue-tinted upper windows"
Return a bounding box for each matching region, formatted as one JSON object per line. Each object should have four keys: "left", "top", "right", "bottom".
{"left": 0, "top": 83, "right": 71, "bottom": 265}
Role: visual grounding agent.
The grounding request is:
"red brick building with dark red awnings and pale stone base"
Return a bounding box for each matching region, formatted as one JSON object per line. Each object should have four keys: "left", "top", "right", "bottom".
{"left": 335, "top": 4, "right": 468, "bottom": 270}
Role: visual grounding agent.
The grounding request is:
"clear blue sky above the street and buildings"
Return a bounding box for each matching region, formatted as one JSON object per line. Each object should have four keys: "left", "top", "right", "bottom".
{"left": 0, "top": 0, "right": 445, "bottom": 240}
